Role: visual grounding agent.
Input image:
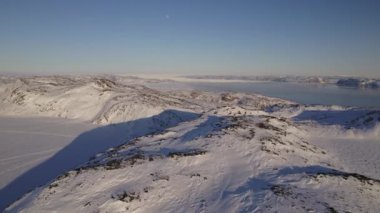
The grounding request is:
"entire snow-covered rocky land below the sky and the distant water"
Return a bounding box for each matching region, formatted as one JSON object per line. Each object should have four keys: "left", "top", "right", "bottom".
{"left": 0, "top": 76, "right": 380, "bottom": 212}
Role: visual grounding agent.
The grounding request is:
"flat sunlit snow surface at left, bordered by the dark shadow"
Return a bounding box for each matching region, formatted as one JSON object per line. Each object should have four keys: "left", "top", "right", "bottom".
{"left": 0, "top": 117, "right": 97, "bottom": 188}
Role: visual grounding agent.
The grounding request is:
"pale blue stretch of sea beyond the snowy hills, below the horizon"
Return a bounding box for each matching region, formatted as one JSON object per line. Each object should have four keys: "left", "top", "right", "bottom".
{"left": 150, "top": 82, "right": 380, "bottom": 109}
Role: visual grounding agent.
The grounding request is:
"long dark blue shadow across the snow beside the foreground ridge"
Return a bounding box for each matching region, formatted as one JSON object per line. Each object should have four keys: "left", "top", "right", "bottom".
{"left": 0, "top": 110, "right": 199, "bottom": 211}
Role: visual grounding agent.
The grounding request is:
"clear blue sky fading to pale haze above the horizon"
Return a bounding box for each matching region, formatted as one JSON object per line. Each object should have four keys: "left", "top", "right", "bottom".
{"left": 0, "top": 0, "right": 380, "bottom": 77}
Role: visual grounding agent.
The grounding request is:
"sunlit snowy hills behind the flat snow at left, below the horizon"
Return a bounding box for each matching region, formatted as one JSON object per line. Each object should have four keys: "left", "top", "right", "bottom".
{"left": 0, "top": 76, "right": 294, "bottom": 124}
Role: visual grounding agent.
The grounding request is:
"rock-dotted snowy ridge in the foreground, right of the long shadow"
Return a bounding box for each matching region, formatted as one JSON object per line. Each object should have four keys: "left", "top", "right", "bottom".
{"left": 9, "top": 108, "right": 380, "bottom": 212}
